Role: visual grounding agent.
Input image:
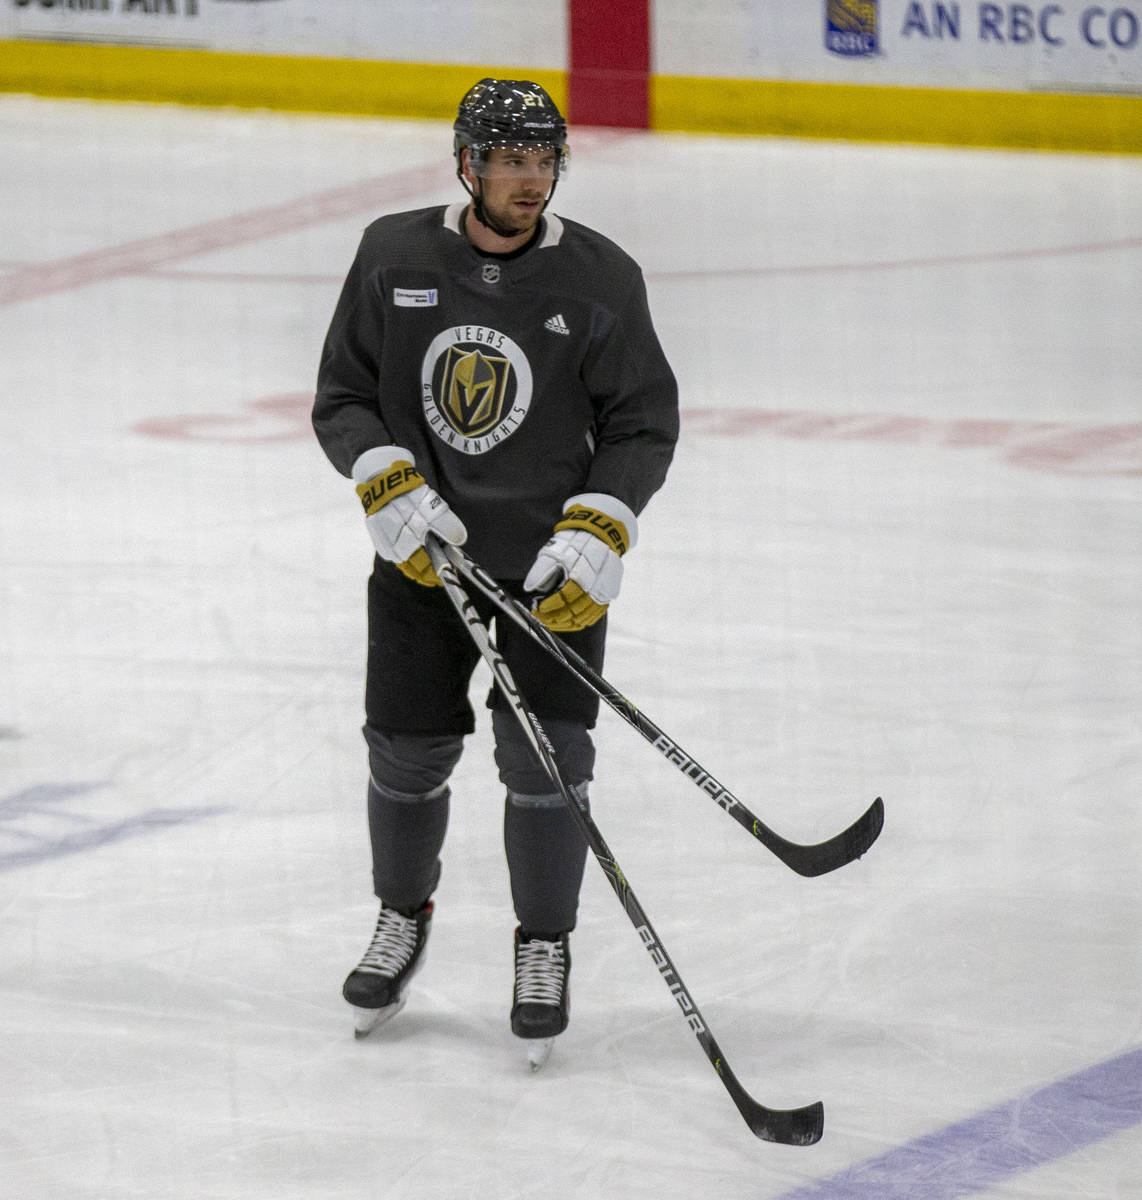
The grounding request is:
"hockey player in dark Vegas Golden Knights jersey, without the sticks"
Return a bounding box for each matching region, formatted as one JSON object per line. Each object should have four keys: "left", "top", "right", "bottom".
{"left": 313, "top": 79, "right": 678, "bottom": 1062}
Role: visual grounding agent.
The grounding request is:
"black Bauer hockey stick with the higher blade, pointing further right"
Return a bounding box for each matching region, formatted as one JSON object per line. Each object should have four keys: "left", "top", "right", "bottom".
{"left": 444, "top": 546, "right": 884, "bottom": 877}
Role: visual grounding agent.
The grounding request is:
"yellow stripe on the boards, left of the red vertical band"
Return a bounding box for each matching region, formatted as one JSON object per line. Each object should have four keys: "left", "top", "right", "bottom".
{"left": 0, "top": 41, "right": 567, "bottom": 120}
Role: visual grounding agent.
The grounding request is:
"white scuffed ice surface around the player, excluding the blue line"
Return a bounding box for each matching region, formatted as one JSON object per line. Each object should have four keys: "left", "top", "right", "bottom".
{"left": 0, "top": 97, "right": 1142, "bottom": 1200}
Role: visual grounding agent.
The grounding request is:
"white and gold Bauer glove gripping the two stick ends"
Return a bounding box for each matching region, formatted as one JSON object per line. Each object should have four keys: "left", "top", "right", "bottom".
{"left": 353, "top": 446, "right": 468, "bottom": 588}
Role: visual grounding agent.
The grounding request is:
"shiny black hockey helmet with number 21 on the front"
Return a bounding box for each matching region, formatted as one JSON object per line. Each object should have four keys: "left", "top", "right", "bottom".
{"left": 452, "top": 79, "right": 567, "bottom": 180}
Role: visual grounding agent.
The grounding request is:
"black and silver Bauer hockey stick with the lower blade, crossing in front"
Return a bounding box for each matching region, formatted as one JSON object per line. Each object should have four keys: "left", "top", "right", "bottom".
{"left": 426, "top": 536, "right": 824, "bottom": 1146}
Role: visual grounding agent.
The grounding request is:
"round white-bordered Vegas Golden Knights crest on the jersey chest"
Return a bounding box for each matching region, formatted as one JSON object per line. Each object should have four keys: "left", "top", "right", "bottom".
{"left": 420, "top": 325, "right": 531, "bottom": 455}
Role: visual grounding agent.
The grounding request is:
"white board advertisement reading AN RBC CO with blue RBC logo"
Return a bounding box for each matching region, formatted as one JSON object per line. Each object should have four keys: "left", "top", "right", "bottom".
{"left": 654, "top": 0, "right": 1142, "bottom": 94}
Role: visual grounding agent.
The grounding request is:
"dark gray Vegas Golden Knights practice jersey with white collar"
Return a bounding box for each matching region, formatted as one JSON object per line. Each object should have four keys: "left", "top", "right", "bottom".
{"left": 313, "top": 203, "right": 678, "bottom": 580}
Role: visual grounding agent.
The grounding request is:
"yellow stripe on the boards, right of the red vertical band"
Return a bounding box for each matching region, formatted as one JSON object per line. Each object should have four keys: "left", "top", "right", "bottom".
{"left": 650, "top": 76, "right": 1142, "bottom": 154}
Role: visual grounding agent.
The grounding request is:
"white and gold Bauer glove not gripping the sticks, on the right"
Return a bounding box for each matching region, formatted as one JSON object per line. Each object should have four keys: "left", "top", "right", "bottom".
{"left": 523, "top": 492, "right": 638, "bottom": 634}
